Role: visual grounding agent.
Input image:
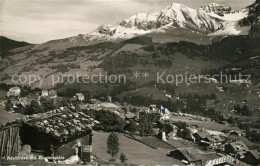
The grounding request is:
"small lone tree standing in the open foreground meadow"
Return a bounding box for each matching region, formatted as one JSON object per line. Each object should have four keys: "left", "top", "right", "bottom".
{"left": 107, "top": 133, "right": 119, "bottom": 159}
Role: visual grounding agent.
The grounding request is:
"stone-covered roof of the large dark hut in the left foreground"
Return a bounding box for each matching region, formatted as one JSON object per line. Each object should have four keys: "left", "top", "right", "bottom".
{"left": 25, "top": 110, "right": 94, "bottom": 142}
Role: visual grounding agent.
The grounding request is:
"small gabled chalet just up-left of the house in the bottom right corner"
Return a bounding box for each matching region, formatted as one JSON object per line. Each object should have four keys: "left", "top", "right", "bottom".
{"left": 225, "top": 141, "right": 248, "bottom": 159}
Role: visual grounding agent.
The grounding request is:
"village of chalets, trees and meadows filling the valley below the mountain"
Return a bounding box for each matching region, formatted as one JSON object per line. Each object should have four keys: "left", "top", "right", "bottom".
{"left": 0, "top": 86, "right": 260, "bottom": 166}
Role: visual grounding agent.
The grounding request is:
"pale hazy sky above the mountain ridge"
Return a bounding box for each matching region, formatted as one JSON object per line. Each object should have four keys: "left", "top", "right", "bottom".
{"left": 0, "top": 0, "right": 254, "bottom": 43}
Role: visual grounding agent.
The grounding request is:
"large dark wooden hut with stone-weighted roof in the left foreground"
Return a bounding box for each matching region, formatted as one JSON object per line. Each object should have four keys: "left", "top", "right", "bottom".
{"left": 21, "top": 110, "right": 94, "bottom": 159}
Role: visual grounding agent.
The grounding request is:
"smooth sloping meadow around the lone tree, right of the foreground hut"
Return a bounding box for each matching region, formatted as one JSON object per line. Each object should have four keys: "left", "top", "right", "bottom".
{"left": 93, "top": 131, "right": 182, "bottom": 165}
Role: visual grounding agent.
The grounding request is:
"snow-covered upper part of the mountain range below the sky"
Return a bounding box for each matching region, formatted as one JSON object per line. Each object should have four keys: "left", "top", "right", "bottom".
{"left": 56, "top": 3, "right": 249, "bottom": 48}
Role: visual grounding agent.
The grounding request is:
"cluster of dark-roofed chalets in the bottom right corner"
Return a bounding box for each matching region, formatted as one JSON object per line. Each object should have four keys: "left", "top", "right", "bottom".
{"left": 167, "top": 126, "right": 260, "bottom": 165}
